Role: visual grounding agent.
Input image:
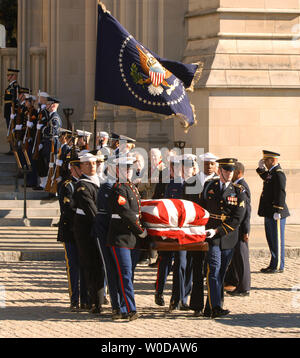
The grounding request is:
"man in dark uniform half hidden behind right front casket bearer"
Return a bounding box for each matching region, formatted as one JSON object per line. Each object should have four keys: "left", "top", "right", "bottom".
{"left": 225, "top": 162, "right": 251, "bottom": 296}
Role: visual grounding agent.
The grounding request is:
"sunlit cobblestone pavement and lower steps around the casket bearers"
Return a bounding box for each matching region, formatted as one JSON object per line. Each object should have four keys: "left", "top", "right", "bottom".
{"left": 0, "top": 227, "right": 300, "bottom": 338}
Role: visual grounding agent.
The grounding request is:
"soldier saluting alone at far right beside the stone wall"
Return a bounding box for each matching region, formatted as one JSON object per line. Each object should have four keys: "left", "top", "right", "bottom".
{"left": 256, "top": 150, "right": 290, "bottom": 273}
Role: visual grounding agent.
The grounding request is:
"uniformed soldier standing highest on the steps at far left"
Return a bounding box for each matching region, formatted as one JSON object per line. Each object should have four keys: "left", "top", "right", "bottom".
{"left": 4, "top": 68, "right": 20, "bottom": 155}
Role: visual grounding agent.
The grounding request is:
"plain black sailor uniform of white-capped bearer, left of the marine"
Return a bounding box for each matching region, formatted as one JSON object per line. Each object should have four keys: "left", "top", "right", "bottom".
{"left": 74, "top": 164, "right": 104, "bottom": 313}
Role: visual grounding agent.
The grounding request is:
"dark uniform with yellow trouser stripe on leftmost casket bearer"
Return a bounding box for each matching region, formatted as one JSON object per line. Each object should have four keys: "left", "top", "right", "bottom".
{"left": 57, "top": 177, "right": 89, "bottom": 309}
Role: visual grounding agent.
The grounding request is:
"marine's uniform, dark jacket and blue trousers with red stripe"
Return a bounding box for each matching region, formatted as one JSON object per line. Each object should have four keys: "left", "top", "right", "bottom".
{"left": 107, "top": 166, "right": 147, "bottom": 319}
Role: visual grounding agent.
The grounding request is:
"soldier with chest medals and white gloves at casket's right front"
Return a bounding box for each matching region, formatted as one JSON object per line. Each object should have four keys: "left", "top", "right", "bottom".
{"left": 200, "top": 158, "right": 246, "bottom": 318}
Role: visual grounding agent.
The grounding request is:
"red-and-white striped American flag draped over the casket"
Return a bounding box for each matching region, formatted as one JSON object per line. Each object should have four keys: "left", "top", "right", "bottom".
{"left": 141, "top": 199, "right": 209, "bottom": 245}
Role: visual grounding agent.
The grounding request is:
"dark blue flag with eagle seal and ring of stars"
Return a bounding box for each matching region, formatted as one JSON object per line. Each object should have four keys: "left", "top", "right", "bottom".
{"left": 95, "top": 2, "right": 202, "bottom": 128}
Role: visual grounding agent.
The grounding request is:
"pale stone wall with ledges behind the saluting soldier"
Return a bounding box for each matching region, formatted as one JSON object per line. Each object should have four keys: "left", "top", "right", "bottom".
{"left": 180, "top": 0, "right": 300, "bottom": 223}
